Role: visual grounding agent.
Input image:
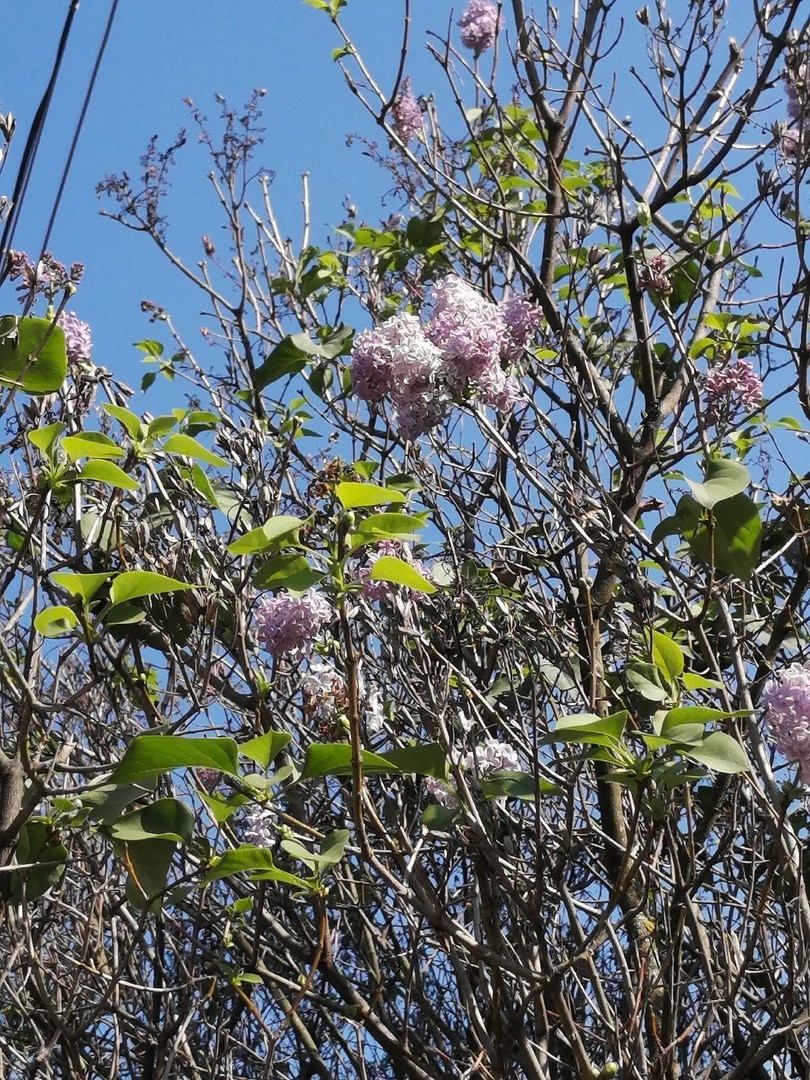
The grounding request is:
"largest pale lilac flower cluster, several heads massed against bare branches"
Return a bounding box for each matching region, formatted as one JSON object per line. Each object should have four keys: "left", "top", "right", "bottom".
{"left": 352, "top": 275, "right": 542, "bottom": 440}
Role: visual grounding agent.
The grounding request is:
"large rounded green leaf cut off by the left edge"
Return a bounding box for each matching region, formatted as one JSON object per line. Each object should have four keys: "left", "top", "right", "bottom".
{"left": 0, "top": 315, "right": 67, "bottom": 394}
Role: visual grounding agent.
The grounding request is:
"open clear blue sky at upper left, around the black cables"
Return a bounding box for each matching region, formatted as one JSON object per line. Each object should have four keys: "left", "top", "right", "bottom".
{"left": 0, "top": 0, "right": 451, "bottom": 393}
